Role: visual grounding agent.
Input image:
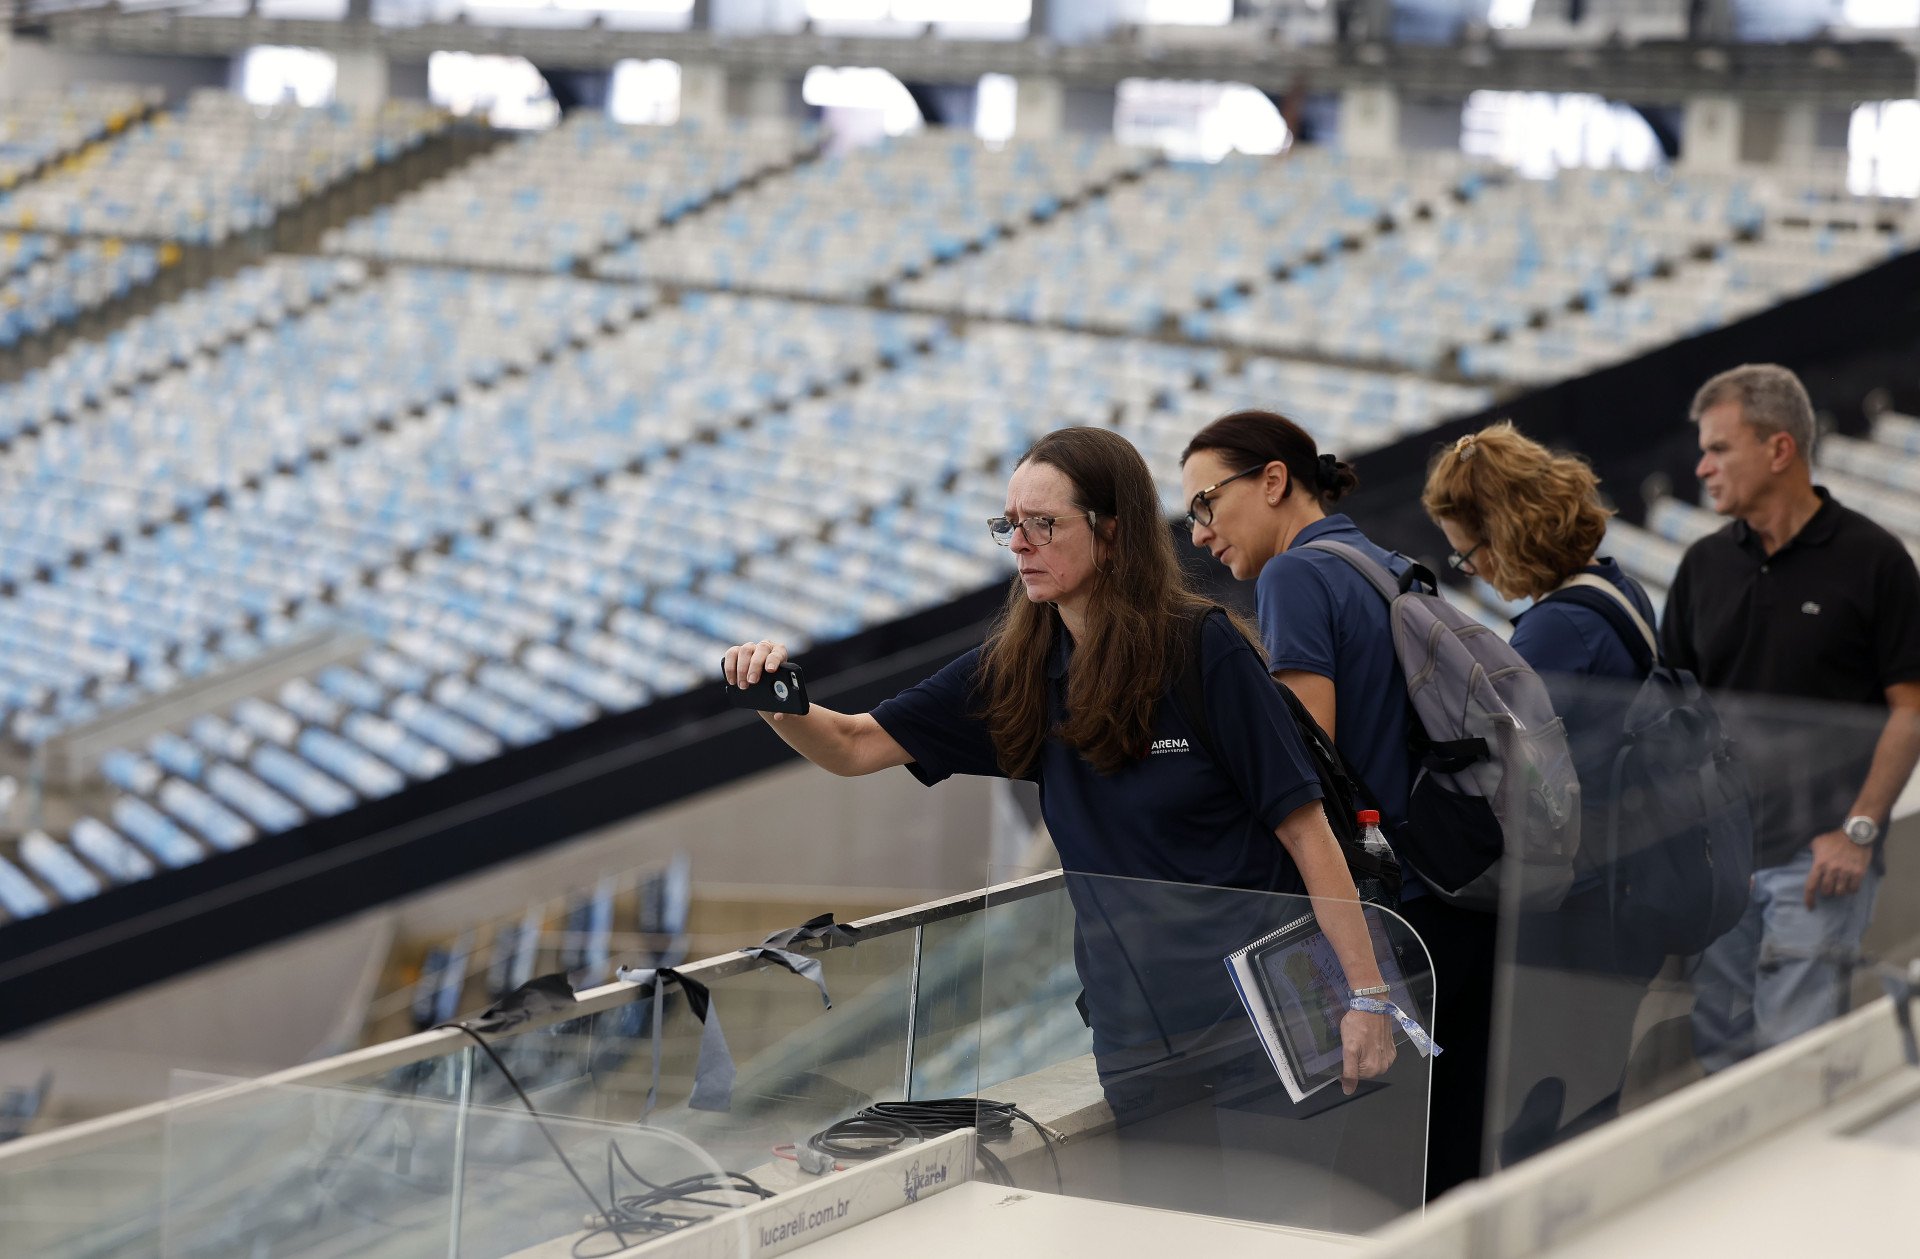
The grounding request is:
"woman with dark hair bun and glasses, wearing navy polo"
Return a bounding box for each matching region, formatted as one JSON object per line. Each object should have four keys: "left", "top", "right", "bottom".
{"left": 1181, "top": 411, "right": 1496, "bottom": 1198}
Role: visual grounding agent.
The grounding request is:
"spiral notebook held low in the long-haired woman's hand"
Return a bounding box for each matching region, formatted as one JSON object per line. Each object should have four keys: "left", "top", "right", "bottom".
{"left": 1225, "top": 910, "right": 1417, "bottom": 1102}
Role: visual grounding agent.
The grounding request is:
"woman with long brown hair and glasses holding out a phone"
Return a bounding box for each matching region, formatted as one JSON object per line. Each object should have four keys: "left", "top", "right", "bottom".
{"left": 724, "top": 428, "right": 1394, "bottom": 1111}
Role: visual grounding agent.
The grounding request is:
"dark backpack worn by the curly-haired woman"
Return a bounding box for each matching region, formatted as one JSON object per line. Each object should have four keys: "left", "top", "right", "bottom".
{"left": 1548, "top": 578, "right": 1753, "bottom": 954}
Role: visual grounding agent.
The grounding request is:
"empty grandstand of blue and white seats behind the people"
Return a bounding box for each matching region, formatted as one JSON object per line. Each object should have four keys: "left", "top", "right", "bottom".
{"left": 0, "top": 61, "right": 1912, "bottom": 982}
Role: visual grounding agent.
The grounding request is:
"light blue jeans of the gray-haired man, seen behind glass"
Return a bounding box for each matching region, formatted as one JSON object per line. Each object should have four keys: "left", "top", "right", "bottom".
{"left": 1693, "top": 848, "right": 1880, "bottom": 1071}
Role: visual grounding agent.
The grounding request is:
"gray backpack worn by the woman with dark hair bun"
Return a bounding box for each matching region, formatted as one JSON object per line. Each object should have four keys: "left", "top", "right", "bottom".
{"left": 1304, "top": 539, "right": 1580, "bottom": 910}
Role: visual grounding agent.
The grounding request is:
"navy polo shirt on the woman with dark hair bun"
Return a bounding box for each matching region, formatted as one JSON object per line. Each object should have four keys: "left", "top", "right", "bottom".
{"left": 1254, "top": 514, "right": 1427, "bottom": 900}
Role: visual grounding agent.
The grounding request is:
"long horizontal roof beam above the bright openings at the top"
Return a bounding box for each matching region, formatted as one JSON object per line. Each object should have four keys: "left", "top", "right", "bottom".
{"left": 18, "top": 10, "right": 1920, "bottom": 106}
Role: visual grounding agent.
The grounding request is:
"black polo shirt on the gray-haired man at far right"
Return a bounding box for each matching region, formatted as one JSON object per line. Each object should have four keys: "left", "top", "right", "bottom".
{"left": 1661, "top": 487, "right": 1920, "bottom": 866}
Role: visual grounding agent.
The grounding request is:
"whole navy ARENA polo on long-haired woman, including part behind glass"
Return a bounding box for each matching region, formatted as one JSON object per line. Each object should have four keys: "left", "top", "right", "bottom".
{"left": 874, "top": 616, "right": 1321, "bottom": 1082}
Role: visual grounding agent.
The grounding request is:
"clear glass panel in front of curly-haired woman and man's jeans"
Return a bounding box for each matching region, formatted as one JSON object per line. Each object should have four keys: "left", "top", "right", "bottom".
{"left": 1482, "top": 677, "right": 1920, "bottom": 1169}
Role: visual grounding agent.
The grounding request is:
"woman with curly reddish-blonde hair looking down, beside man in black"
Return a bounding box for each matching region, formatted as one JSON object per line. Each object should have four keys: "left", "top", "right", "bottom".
{"left": 1421, "top": 422, "right": 1665, "bottom": 1163}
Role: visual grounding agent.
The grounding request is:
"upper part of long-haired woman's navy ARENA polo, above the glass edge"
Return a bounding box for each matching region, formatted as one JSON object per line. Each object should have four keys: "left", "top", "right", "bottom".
{"left": 874, "top": 616, "right": 1321, "bottom": 892}
